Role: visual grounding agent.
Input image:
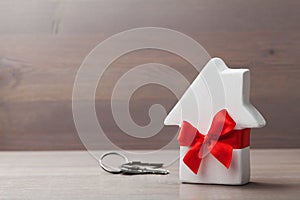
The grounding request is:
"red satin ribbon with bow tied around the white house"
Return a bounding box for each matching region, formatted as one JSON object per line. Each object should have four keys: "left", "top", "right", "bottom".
{"left": 178, "top": 109, "right": 250, "bottom": 174}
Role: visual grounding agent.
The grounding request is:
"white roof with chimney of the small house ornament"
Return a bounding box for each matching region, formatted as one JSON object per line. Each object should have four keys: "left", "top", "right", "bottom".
{"left": 164, "top": 58, "right": 266, "bottom": 132}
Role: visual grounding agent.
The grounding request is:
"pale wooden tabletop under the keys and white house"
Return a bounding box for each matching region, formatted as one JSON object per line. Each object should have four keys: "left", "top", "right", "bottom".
{"left": 0, "top": 149, "right": 300, "bottom": 200}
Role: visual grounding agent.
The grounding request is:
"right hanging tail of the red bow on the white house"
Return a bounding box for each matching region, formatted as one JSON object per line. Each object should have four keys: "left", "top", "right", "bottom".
{"left": 210, "top": 142, "right": 233, "bottom": 169}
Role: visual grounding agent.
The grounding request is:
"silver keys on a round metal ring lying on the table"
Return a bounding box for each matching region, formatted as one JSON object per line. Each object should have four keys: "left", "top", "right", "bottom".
{"left": 99, "top": 152, "right": 169, "bottom": 175}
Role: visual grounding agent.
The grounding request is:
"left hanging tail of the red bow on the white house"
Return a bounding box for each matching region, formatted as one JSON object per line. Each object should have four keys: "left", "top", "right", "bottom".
{"left": 183, "top": 144, "right": 202, "bottom": 174}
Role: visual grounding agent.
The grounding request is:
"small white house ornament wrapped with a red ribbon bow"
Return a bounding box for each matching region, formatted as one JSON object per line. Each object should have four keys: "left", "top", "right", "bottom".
{"left": 164, "top": 58, "right": 266, "bottom": 185}
